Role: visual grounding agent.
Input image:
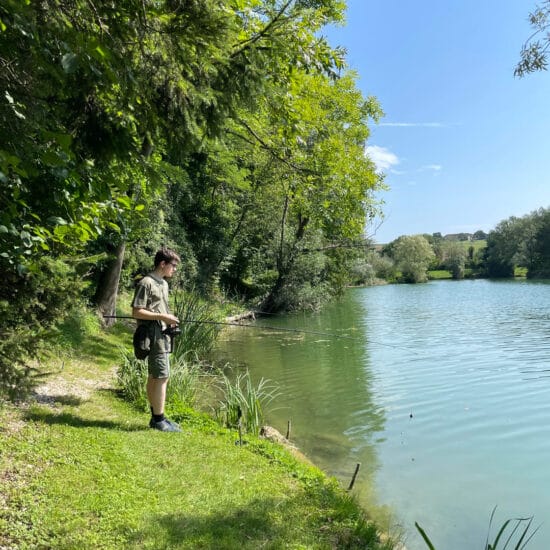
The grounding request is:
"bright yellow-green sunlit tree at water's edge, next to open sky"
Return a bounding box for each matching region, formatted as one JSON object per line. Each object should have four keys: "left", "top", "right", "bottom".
{"left": 237, "top": 73, "right": 382, "bottom": 311}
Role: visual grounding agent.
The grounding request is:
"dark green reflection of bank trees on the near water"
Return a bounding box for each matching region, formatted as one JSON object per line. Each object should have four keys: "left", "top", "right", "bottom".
{"left": 218, "top": 300, "right": 385, "bottom": 494}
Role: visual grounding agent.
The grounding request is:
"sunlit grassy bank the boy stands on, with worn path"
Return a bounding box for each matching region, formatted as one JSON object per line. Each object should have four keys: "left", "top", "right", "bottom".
{"left": 0, "top": 314, "right": 395, "bottom": 549}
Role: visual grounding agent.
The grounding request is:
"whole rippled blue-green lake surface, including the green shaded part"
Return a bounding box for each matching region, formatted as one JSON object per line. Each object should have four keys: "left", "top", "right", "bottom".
{"left": 215, "top": 280, "right": 550, "bottom": 550}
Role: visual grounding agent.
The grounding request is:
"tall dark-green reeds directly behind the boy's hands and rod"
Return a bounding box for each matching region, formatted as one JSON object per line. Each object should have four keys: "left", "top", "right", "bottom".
{"left": 172, "top": 290, "right": 221, "bottom": 359}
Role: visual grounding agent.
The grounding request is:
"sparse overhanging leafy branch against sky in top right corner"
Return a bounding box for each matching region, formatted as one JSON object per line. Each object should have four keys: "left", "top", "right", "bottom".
{"left": 514, "top": 0, "right": 550, "bottom": 77}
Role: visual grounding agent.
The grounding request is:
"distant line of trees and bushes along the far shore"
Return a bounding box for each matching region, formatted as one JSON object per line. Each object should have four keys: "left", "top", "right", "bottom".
{"left": 354, "top": 208, "right": 550, "bottom": 284}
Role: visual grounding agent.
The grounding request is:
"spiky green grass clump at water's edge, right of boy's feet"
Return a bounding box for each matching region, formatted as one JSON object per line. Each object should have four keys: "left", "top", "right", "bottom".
{"left": 214, "top": 371, "right": 279, "bottom": 435}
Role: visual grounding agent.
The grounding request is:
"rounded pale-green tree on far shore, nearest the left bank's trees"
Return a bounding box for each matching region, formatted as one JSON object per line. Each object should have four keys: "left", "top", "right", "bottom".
{"left": 392, "top": 235, "right": 435, "bottom": 283}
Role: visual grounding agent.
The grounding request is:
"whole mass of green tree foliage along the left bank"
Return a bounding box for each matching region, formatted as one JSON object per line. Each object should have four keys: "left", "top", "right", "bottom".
{"left": 0, "top": 0, "right": 388, "bottom": 392}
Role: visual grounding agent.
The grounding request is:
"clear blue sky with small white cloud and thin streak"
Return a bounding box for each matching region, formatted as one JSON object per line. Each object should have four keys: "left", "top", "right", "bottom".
{"left": 324, "top": 0, "right": 550, "bottom": 243}
